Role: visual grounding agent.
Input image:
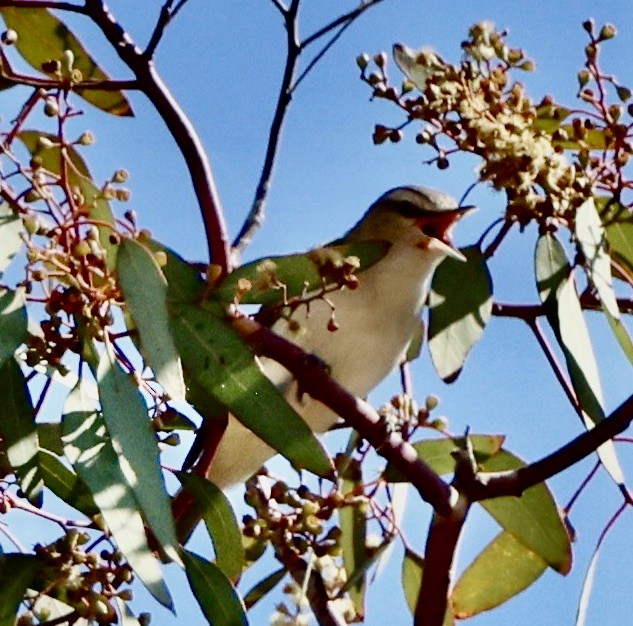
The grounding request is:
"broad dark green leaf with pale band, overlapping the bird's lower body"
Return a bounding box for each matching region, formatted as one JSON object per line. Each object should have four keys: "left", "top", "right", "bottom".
{"left": 170, "top": 304, "right": 332, "bottom": 477}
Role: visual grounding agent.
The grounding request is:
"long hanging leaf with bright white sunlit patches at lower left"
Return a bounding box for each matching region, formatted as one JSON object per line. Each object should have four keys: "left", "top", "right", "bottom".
{"left": 62, "top": 381, "right": 173, "bottom": 610}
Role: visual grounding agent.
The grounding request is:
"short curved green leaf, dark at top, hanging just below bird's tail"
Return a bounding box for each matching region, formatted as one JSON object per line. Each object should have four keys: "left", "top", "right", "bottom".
{"left": 176, "top": 472, "right": 245, "bottom": 580}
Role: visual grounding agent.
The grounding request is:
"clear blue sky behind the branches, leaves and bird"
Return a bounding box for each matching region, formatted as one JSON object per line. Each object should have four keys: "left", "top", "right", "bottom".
{"left": 7, "top": 0, "right": 633, "bottom": 626}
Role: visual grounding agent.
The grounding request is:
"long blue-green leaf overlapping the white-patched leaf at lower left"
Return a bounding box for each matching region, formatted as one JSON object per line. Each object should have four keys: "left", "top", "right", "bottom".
{"left": 97, "top": 352, "right": 180, "bottom": 563}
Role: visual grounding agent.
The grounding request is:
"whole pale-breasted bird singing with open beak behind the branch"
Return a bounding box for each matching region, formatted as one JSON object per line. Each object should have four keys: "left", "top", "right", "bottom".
{"left": 209, "top": 186, "right": 473, "bottom": 488}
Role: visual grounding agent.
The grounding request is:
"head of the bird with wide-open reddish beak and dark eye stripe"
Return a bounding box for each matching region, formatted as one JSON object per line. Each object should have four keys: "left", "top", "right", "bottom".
{"left": 346, "top": 185, "right": 474, "bottom": 261}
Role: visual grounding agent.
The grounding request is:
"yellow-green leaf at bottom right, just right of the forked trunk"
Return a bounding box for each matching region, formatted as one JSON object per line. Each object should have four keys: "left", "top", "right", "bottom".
{"left": 451, "top": 532, "right": 547, "bottom": 619}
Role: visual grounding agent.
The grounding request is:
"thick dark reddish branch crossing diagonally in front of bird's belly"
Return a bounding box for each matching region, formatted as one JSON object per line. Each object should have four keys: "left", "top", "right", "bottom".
{"left": 233, "top": 317, "right": 452, "bottom": 516}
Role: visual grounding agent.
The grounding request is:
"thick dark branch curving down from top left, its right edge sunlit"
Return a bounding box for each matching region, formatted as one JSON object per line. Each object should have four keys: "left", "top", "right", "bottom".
{"left": 85, "top": 0, "right": 231, "bottom": 274}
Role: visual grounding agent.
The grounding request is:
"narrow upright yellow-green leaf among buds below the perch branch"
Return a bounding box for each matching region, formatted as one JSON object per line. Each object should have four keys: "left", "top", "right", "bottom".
{"left": 338, "top": 459, "right": 368, "bottom": 618}
